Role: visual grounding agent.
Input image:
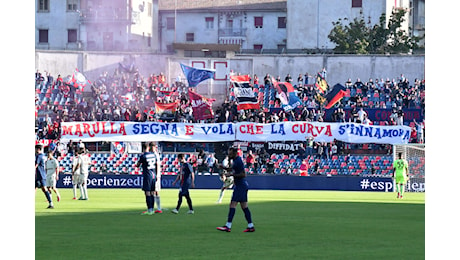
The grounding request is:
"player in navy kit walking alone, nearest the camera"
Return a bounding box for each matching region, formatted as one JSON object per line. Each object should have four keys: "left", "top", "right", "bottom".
{"left": 217, "top": 147, "right": 255, "bottom": 232}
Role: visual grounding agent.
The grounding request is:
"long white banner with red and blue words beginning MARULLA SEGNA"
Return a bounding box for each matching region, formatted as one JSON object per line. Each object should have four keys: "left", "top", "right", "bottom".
{"left": 61, "top": 121, "right": 411, "bottom": 144}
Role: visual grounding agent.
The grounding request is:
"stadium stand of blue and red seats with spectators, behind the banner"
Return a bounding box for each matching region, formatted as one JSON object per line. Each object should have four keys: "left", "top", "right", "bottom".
{"left": 35, "top": 69, "right": 425, "bottom": 176}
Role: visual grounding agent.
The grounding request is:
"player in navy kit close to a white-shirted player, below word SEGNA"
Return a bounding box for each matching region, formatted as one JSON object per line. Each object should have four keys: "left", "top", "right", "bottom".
{"left": 137, "top": 143, "right": 161, "bottom": 215}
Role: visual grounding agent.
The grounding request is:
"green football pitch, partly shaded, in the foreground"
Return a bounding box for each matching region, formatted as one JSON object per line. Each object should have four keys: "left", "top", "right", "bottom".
{"left": 35, "top": 189, "right": 425, "bottom": 260}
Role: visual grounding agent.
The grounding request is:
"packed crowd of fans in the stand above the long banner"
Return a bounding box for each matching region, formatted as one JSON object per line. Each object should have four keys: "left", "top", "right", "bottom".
{"left": 35, "top": 66, "right": 425, "bottom": 141}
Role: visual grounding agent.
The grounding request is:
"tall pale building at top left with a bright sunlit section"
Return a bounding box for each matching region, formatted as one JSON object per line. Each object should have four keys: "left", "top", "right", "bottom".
{"left": 35, "top": 0, "right": 158, "bottom": 51}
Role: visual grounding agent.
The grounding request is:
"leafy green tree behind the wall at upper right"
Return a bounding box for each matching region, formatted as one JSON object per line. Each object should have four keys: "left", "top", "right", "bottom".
{"left": 328, "top": 9, "right": 423, "bottom": 54}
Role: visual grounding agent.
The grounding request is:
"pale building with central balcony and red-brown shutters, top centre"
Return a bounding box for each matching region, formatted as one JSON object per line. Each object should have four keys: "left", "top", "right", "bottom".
{"left": 159, "top": 1, "right": 287, "bottom": 56}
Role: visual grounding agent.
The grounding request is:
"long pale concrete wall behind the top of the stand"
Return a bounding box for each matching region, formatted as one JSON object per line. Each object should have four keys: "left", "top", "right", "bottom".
{"left": 35, "top": 51, "right": 425, "bottom": 103}
